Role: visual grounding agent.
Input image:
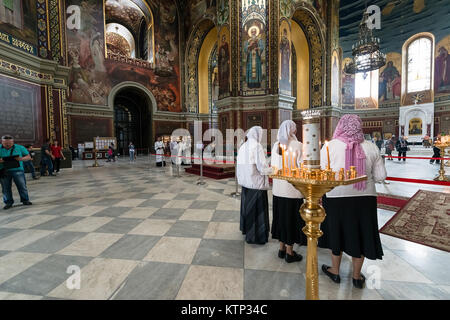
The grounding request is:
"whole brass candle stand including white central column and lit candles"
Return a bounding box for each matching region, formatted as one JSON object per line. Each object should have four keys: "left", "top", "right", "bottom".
{"left": 270, "top": 110, "right": 367, "bottom": 300}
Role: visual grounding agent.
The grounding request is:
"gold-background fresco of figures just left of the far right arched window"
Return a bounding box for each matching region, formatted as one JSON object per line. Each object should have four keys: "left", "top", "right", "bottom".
{"left": 378, "top": 52, "right": 402, "bottom": 102}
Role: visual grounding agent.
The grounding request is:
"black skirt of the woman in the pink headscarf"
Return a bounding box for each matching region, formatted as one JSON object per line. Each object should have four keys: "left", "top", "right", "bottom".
{"left": 318, "top": 196, "right": 383, "bottom": 260}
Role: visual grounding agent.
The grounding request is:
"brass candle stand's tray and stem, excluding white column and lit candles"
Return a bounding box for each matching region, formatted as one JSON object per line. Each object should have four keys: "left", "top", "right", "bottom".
{"left": 270, "top": 167, "right": 367, "bottom": 300}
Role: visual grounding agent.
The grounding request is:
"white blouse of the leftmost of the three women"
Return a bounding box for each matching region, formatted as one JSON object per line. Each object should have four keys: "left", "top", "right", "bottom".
{"left": 236, "top": 139, "right": 272, "bottom": 190}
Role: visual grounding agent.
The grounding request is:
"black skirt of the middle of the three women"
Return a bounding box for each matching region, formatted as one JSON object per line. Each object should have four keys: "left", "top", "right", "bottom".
{"left": 272, "top": 196, "right": 307, "bottom": 246}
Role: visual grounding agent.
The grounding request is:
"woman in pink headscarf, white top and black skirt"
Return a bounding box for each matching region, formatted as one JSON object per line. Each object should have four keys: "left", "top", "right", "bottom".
{"left": 319, "top": 114, "right": 386, "bottom": 289}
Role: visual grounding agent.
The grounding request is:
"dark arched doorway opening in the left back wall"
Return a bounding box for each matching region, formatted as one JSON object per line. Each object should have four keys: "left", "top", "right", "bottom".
{"left": 114, "top": 87, "right": 152, "bottom": 154}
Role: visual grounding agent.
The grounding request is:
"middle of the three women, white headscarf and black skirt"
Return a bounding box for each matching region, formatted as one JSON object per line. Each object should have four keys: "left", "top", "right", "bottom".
{"left": 271, "top": 120, "right": 307, "bottom": 263}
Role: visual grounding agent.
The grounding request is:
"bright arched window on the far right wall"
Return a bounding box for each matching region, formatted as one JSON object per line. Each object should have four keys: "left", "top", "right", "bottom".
{"left": 406, "top": 37, "right": 433, "bottom": 93}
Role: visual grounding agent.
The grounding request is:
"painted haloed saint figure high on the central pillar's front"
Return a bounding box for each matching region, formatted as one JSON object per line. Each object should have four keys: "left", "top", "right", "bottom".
{"left": 244, "top": 26, "right": 264, "bottom": 89}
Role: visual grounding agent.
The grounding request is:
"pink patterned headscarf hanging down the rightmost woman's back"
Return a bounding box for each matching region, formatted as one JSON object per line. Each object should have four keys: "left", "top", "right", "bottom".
{"left": 333, "top": 114, "right": 366, "bottom": 190}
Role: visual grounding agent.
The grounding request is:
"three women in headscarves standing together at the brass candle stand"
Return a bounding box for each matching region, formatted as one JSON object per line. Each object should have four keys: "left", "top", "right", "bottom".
{"left": 236, "top": 115, "right": 386, "bottom": 288}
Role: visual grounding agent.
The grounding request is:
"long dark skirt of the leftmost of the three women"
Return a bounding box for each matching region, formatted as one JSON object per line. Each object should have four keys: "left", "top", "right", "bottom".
{"left": 240, "top": 187, "right": 270, "bottom": 244}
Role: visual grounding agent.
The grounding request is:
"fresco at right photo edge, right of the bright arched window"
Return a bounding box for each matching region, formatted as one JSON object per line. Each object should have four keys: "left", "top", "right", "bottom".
{"left": 434, "top": 35, "right": 450, "bottom": 93}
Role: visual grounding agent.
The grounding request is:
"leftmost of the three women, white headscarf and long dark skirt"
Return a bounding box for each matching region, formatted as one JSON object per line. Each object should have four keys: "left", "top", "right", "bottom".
{"left": 236, "top": 126, "right": 272, "bottom": 244}
